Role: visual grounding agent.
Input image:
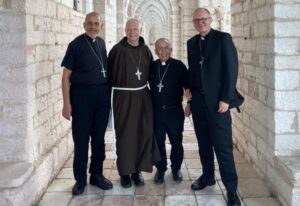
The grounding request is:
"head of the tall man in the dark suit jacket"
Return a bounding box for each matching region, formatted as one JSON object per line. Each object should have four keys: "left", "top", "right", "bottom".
{"left": 193, "top": 8, "right": 212, "bottom": 36}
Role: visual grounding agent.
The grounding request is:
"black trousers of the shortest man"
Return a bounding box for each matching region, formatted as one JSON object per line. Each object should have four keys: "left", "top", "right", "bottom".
{"left": 154, "top": 106, "right": 184, "bottom": 171}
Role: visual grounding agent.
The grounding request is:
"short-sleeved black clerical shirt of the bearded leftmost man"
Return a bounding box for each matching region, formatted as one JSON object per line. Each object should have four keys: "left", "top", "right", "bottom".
{"left": 61, "top": 34, "right": 107, "bottom": 84}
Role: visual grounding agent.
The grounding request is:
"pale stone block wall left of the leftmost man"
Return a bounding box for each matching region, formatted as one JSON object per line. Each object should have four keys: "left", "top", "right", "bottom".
{"left": 0, "top": 0, "right": 84, "bottom": 205}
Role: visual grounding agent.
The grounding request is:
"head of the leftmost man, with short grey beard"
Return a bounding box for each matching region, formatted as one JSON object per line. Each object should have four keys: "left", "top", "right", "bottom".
{"left": 83, "top": 12, "right": 102, "bottom": 39}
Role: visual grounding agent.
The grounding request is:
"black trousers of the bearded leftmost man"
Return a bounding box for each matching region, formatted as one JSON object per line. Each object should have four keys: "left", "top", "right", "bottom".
{"left": 70, "top": 84, "right": 110, "bottom": 182}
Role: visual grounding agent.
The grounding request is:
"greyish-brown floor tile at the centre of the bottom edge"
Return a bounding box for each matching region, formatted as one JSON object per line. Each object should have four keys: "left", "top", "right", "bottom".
{"left": 133, "top": 195, "right": 165, "bottom": 206}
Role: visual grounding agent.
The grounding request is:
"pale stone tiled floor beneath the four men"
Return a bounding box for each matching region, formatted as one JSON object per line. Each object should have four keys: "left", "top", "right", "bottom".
{"left": 38, "top": 119, "right": 280, "bottom": 206}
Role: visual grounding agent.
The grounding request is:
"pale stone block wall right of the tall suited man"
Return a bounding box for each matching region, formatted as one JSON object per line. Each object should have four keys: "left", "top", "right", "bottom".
{"left": 231, "top": 0, "right": 300, "bottom": 205}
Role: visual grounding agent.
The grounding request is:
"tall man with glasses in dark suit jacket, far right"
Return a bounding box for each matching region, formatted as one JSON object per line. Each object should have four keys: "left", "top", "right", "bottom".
{"left": 186, "top": 8, "right": 241, "bottom": 205}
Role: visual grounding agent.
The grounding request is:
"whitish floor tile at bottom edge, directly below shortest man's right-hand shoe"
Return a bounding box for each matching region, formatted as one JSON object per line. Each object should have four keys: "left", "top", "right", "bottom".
{"left": 165, "top": 195, "right": 197, "bottom": 206}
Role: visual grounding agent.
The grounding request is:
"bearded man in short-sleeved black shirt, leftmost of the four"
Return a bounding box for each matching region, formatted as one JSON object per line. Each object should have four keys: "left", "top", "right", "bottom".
{"left": 61, "top": 12, "right": 113, "bottom": 195}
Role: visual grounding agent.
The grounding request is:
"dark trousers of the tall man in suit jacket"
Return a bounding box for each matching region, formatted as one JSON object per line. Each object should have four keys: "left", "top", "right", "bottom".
{"left": 191, "top": 92, "right": 238, "bottom": 192}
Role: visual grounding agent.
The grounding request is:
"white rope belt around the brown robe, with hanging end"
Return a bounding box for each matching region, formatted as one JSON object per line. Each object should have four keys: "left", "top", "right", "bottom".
{"left": 110, "top": 84, "right": 148, "bottom": 161}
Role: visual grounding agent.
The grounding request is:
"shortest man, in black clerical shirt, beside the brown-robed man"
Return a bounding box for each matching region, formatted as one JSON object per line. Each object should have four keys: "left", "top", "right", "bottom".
{"left": 149, "top": 38, "right": 187, "bottom": 184}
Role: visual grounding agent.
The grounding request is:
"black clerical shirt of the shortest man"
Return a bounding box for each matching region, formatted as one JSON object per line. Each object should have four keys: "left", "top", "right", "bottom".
{"left": 149, "top": 58, "right": 188, "bottom": 109}
